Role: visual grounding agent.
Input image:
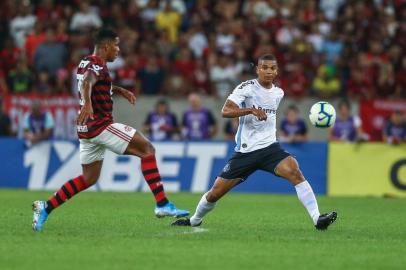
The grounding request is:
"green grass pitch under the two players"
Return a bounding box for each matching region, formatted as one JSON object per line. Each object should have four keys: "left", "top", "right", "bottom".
{"left": 0, "top": 190, "right": 406, "bottom": 270}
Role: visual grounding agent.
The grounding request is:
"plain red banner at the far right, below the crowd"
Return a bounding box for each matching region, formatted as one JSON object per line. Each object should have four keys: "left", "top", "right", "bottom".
{"left": 360, "top": 100, "right": 406, "bottom": 141}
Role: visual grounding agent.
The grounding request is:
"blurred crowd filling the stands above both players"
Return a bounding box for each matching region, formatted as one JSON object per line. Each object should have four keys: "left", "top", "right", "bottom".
{"left": 0, "top": 0, "right": 406, "bottom": 99}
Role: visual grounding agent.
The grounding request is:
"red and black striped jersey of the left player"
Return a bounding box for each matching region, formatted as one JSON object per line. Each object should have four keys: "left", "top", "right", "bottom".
{"left": 76, "top": 55, "right": 113, "bottom": 139}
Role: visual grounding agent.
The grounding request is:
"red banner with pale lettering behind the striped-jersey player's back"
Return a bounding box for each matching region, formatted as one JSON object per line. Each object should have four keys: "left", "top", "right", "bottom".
{"left": 3, "top": 95, "right": 79, "bottom": 139}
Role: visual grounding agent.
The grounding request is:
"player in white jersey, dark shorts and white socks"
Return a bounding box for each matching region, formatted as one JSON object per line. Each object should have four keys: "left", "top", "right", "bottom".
{"left": 172, "top": 54, "right": 337, "bottom": 230}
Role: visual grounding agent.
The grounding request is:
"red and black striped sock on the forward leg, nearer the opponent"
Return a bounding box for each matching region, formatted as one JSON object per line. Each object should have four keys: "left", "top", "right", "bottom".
{"left": 141, "top": 155, "right": 169, "bottom": 206}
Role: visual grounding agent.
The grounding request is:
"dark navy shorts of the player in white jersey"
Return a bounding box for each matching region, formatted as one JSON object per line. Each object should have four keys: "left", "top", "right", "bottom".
{"left": 219, "top": 142, "right": 290, "bottom": 181}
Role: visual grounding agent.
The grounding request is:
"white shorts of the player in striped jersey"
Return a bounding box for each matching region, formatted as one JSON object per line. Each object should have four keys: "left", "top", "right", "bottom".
{"left": 79, "top": 123, "right": 136, "bottom": 164}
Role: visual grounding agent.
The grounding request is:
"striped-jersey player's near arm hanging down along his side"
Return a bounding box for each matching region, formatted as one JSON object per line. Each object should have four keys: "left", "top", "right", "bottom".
{"left": 78, "top": 71, "right": 97, "bottom": 126}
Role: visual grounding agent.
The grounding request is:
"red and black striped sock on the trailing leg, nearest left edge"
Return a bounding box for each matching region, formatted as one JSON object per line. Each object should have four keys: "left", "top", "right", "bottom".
{"left": 46, "top": 175, "right": 89, "bottom": 214}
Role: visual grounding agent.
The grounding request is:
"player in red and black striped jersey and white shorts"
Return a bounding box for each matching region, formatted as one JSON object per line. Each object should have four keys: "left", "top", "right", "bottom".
{"left": 32, "top": 29, "right": 189, "bottom": 231}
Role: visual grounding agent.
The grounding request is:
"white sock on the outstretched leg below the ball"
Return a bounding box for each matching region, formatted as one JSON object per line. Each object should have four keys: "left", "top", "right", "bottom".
{"left": 295, "top": 180, "right": 320, "bottom": 225}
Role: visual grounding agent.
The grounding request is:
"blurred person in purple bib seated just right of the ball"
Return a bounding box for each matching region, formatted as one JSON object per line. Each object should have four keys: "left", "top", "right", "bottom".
{"left": 328, "top": 100, "right": 365, "bottom": 142}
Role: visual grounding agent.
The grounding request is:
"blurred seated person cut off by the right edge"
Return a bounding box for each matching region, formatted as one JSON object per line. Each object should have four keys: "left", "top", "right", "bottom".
{"left": 383, "top": 111, "right": 406, "bottom": 145}
